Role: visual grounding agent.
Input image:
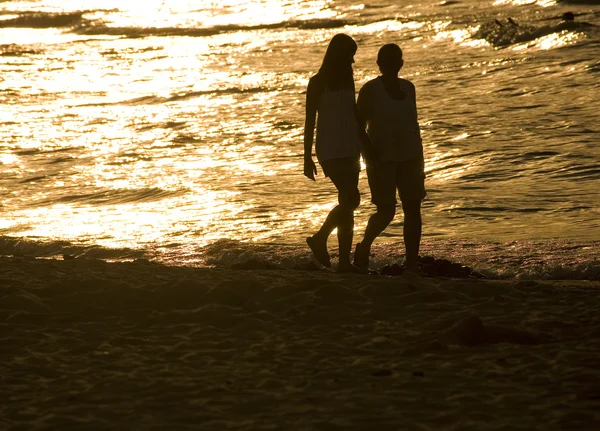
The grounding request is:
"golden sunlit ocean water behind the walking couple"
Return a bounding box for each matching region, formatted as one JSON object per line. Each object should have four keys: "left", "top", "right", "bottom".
{"left": 0, "top": 0, "right": 600, "bottom": 278}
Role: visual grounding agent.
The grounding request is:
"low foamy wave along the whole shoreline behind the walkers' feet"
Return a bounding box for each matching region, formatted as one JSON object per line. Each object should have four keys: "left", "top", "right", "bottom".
{"left": 0, "top": 236, "right": 600, "bottom": 281}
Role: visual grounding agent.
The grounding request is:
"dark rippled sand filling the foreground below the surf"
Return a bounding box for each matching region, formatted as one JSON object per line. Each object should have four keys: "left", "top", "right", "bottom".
{"left": 0, "top": 258, "right": 600, "bottom": 431}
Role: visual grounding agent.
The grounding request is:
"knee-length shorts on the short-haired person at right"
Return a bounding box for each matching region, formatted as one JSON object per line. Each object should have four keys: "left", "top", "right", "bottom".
{"left": 367, "top": 160, "right": 427, "bottom": 205}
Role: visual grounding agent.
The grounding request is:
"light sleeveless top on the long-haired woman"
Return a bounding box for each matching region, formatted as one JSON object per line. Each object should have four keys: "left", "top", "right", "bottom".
{"left": 315, "top": 89, "right": 360, "bottom": 162}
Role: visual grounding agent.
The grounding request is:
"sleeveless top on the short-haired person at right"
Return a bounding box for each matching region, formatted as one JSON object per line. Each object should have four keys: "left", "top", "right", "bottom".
{"left": 359, "top": 78, "right": 423, "bottom": 162}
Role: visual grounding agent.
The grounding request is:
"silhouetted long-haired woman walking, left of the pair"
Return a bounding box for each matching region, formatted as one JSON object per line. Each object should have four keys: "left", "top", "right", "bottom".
{"left": 304, "top": 34, "right": 366, "bottom": 272}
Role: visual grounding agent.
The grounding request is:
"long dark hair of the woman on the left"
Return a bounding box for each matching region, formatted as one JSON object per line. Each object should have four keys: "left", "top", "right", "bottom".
{"left": 317, "top": 33, "right": 358, "bottom": 90}
